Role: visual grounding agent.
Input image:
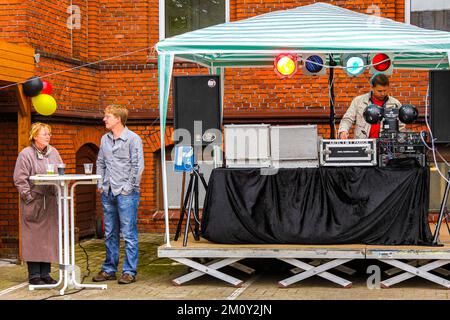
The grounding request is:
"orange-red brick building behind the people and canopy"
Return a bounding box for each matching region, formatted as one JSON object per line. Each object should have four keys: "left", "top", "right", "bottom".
{"left": 0, "top": 0, "right": 444, "bottom": 258}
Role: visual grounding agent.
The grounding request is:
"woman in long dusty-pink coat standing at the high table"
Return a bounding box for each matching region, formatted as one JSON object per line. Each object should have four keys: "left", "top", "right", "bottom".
{"left": 14, "top": 122, "right": 62, "bottom": 285}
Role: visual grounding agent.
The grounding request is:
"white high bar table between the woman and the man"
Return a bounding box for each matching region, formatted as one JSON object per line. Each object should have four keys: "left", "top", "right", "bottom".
{"left": 28, "top": 174, "right": 107, "bottom": 295}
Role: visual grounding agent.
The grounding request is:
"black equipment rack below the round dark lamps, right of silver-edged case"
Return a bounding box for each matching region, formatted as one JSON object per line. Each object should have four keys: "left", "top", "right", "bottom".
{"left": 378, "top": 132, "right": 427, "bottom": 167}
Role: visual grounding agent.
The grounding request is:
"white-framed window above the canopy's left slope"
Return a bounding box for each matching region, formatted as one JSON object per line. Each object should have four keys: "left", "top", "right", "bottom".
{"left": 159, "top": 0, "right": 229, "bottom": 40}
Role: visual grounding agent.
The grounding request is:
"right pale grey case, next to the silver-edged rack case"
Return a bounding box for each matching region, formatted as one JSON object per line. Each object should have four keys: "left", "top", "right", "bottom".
{"left": 270, "top": 125, "right": 319, "bottom": 168}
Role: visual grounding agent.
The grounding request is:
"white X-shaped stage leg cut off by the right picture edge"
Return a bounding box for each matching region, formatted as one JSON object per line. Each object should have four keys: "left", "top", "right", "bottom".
{"left": 379, "top": 259, "right": 450, "bottom": 289}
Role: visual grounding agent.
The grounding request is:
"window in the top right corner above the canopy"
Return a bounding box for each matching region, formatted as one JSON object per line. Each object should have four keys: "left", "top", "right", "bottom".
{"left": 406, "top": 0, "right": 450, "bottom": 31}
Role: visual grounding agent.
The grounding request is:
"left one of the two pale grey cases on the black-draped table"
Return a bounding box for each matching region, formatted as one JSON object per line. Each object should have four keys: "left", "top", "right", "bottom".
{"left": 224, "top": 124, "right": 271, "bottom": 168}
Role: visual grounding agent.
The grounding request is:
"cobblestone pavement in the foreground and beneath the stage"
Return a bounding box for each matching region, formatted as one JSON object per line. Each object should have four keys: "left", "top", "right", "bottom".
{"left": 0, "top": 234, "right": 450, "bottom": 300}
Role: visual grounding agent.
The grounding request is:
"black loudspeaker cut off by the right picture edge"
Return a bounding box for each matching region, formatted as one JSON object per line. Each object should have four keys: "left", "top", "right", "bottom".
{"left": 430, "top": 70, "right": 450, "bottom": 143}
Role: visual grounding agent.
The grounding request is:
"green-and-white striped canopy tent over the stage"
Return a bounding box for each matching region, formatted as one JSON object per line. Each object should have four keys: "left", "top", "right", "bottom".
{"left": 156, "top": 3, "right": 450, "bottom": 246}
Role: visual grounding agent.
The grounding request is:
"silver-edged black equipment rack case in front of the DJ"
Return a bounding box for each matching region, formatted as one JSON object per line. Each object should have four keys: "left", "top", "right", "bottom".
{"left": 319, "top": 139, "right": 377, "bottom": 167}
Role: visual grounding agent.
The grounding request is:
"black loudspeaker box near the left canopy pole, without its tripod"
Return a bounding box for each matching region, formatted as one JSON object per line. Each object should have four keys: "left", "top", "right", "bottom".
{"left": 173, "top": 75, "right": 221, "bottom": 146}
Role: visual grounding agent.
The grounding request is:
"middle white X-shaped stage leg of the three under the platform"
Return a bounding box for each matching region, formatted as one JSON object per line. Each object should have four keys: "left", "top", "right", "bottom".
{"left": 278, "top": 258, "right": 353, "bottom": 288}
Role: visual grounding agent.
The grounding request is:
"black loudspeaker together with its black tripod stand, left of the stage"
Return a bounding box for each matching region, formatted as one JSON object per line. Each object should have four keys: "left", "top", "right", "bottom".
{"left": 173, "top": 75, "right": 221, "bottom": 246}
